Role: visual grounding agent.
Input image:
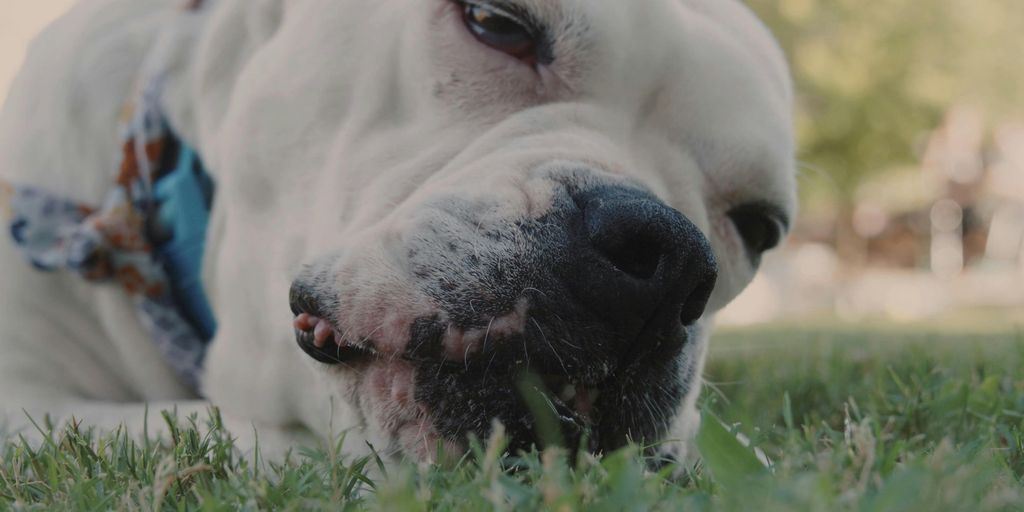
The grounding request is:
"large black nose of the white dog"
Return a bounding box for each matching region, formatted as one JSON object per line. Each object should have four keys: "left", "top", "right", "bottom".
{"left": 569, "top": 186, "right": 718, "bottom": 332}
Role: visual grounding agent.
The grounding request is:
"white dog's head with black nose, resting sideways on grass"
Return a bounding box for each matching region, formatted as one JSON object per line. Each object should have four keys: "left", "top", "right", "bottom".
{"left": 193, "top": 0, "right": 795, "bottom": 457}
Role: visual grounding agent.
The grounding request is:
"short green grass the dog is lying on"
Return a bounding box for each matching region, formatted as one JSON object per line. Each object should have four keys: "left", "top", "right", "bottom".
{"left": 0, "top": 326, "right": 1024, "bottom": 512}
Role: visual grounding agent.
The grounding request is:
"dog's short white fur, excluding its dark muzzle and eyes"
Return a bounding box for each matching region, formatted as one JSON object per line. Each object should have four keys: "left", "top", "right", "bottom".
{"left": 0, "top": 0, "right": 796, "bottom": 462}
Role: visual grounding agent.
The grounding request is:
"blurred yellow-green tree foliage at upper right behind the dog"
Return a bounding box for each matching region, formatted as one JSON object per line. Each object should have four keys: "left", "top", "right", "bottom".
{"left": 748, "top": 0, "right": 1024, "bottom": 260}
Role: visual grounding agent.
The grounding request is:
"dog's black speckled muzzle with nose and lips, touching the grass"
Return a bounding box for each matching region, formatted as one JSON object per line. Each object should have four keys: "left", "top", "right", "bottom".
{"left": 291, "top": 186, "right": 717, "bottom": 450}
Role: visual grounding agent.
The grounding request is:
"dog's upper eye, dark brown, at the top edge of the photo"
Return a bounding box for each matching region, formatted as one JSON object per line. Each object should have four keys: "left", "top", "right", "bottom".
{"left": 462, "top": 1, "right": 538, "bottom": 61}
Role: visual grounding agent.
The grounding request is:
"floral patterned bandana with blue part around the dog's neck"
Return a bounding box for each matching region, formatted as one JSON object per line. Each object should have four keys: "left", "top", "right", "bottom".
{"left": 0, "top": 0, "right": 216, "bottom": 391}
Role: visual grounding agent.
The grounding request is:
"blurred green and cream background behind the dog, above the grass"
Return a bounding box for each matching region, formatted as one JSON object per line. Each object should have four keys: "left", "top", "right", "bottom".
{"left": 0, "top": 0, "right": 1024, "bottom": 326}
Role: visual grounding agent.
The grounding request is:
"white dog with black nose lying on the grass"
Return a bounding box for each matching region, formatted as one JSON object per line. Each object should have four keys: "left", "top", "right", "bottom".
{"left": 0, "top": 0, "right": 796, "bottom": 459}
